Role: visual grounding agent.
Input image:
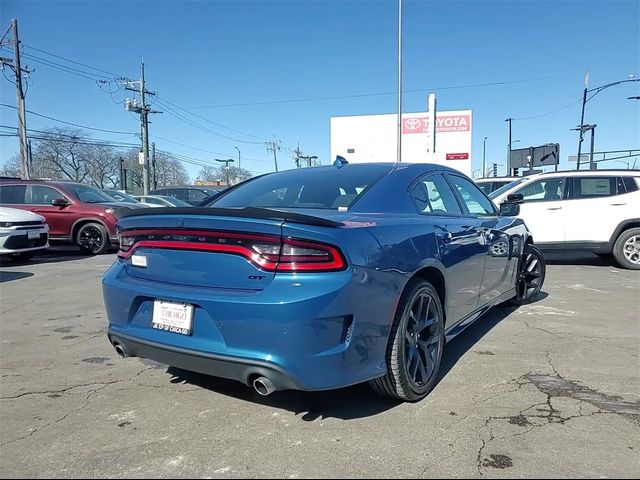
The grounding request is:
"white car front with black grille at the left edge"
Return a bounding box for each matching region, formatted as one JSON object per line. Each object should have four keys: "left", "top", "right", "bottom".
{"left": 0, "top": 207, "right": 49, "bottom": 260}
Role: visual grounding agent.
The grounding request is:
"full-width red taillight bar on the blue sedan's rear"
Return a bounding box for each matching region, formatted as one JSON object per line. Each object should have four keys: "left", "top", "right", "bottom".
{"left": 118, "top": 230, "right": 347, "bottom": 272}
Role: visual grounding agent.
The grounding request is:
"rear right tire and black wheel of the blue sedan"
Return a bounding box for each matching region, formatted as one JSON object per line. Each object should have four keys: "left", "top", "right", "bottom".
{"left": 370, "top": 279, "right": 445, "bottom": 402}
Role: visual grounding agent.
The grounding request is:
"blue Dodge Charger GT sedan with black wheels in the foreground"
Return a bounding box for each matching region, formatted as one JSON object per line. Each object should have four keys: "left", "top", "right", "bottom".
{"left": 103, "top": 163, "right": 545, "bottom": 401}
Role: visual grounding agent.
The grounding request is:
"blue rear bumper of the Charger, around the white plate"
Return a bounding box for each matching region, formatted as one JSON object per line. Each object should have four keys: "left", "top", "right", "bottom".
{"left": 103, "top": 261, "right": 404, "bottom": 391}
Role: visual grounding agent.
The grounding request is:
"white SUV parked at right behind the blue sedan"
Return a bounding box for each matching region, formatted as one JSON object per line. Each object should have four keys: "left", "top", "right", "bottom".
{"left": 490, "top": 170, "right": 640, "bottom": 270}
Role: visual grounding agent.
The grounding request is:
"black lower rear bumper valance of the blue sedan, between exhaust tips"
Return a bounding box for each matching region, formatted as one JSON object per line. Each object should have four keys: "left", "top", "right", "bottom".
{"left": 108, "top": 331, "right": 305, "bottom": 390}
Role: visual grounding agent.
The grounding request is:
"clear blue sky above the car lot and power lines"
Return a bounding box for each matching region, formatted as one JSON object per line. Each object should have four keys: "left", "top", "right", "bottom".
{"left": 0, "top": 0, "right": 640, "bottom": 177}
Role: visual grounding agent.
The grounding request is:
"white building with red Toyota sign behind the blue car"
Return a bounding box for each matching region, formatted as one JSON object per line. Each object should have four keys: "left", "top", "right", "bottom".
{"left": 331, "top": 102, "right": 472, "bottom": 176}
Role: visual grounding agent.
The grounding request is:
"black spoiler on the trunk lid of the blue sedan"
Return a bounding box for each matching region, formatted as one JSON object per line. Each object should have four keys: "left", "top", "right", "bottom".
{"left": 113, "top": 207, "right": 344, "bottom": 228}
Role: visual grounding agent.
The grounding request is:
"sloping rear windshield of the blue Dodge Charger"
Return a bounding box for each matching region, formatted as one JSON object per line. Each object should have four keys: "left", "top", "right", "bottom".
{"left": 209, "top": 165, "right": 390, "bottom": 209}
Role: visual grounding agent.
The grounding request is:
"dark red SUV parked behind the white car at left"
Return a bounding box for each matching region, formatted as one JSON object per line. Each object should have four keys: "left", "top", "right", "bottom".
{"left": 0, "top": 178, "right": 144, "bottom": 255}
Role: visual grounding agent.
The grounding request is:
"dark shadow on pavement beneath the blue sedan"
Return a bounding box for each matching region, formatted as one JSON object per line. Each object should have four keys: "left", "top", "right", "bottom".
{"left": 162, "top": 292, "right": 548, "bottom": 422}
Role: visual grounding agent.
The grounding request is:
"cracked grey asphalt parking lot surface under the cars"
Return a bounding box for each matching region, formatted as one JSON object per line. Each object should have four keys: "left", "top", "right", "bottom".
{"left": 0, "top": 251, "right": 640, "bottom": 478}
